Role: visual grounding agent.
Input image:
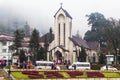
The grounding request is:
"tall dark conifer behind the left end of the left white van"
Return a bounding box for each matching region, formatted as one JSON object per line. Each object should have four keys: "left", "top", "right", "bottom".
{"left": 29, "top": 29, "right": 40, "bottom": 63}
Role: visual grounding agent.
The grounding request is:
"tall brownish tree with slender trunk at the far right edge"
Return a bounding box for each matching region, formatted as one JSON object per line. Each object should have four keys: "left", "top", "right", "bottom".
{"left": 103, "top": 19, "right": 120, "bottom": 64}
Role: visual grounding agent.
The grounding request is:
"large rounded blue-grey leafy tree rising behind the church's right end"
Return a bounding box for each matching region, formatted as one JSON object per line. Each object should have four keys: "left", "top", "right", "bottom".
{"left": 84, "top": 12, "right": 108, "bottom": 41}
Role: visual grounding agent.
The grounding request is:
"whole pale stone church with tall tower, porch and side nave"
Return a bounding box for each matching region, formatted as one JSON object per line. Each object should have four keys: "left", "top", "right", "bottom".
{"left": 47, "top": 6, "right": 99, "bottom": 63}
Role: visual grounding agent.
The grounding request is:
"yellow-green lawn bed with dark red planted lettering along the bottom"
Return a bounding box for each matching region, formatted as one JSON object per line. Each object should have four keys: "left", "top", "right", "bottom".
{"left": 11, "top": 71, "right": 120, "bottom": 79}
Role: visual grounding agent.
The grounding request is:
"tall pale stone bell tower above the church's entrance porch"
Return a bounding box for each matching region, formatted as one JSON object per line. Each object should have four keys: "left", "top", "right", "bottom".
{"left": 54, "top": 5, "right": 72, "bottom": 50}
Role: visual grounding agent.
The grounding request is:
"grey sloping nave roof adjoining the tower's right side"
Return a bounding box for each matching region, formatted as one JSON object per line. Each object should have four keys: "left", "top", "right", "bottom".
{"left": 70, "top": 36, "right": 89, "bottom": 48}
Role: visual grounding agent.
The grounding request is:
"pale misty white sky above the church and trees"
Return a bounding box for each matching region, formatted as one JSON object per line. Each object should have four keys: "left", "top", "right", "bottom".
{"left": 0, "top": 0, "right": 120, "bottom": 36}
